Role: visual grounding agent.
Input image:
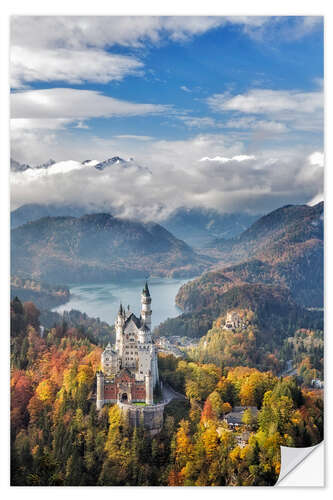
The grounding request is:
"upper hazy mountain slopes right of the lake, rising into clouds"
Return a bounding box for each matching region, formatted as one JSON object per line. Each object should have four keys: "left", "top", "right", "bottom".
{"left": 176, "top": 203, "right": 324, "bottom": 311}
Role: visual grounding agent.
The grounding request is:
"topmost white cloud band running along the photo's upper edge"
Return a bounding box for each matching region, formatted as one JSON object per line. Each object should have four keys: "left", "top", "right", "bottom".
{"left": 11, "top": 16, "right": 323, "bottom": 48}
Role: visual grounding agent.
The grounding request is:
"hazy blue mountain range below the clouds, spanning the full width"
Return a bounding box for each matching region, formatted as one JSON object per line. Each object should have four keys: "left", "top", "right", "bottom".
{"left": 11, "top": 193, "right": 324, "bottom": 317}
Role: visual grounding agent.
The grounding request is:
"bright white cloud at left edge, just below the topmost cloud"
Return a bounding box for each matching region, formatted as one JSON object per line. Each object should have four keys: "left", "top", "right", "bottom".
{"left": 11, "top": 46, "right": 143, "bottom": 88}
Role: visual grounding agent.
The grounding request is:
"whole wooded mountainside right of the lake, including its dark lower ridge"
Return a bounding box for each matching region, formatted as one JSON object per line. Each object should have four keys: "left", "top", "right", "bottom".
{"left": 155, "top": 203, "right": 324, "bottom": 338}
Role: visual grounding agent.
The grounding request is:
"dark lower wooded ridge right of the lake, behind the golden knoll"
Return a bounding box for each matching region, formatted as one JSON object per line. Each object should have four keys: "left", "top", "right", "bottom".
{"left": 154, "top": 282, "right": 323, "bottom": 340}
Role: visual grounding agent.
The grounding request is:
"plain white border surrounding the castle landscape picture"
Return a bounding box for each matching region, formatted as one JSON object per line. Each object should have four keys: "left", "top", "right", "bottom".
{"left": 0, "top": 0, "right": 333, "bottom": 500}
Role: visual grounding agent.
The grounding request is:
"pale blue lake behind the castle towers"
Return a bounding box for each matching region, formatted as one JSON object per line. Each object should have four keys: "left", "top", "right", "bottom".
{"left": 53, "top": 278, "right": 193, "bottom": 327}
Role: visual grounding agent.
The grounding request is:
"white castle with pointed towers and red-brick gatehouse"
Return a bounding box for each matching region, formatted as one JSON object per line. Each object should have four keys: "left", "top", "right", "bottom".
{"left": 96, "top": 282, "right": 160, "bottom": 412}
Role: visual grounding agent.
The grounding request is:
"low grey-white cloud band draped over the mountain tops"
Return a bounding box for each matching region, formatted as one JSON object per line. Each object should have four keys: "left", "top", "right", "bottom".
{"left": 11, "top": 145, "right": 323, "bottom": 221}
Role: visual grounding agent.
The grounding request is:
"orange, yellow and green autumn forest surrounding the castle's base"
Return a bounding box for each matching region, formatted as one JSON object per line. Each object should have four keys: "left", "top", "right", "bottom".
{"left": 11, "top": 298, "right": 323, "bottom": 486}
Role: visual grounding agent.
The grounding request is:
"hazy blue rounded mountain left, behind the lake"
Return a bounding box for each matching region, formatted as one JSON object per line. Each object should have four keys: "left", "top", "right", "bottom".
{"left": 11, "top": 213, "right": 209, "bottom": 284}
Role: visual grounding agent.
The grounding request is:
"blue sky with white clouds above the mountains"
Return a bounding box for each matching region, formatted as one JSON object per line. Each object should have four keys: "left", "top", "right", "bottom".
{"left": 11, "top": 16, "right": 324, "bottom": 217}
